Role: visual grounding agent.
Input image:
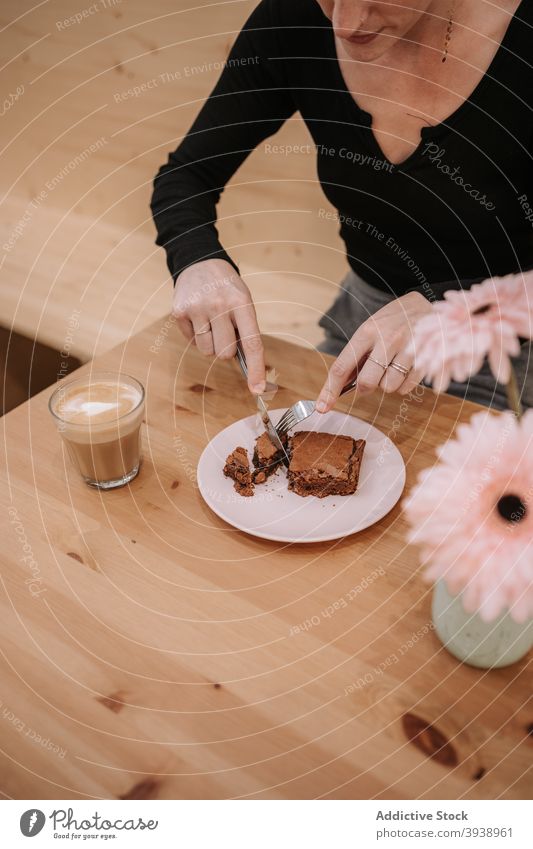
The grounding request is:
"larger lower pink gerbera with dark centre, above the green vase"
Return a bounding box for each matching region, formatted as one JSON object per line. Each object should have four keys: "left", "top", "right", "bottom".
{"left": 405, "top": 410, "right": 533, "bottom": 622}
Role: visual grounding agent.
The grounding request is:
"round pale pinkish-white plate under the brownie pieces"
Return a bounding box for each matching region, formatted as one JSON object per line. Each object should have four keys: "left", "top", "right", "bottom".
{"left": 198, "top": 410, "right": 405, "bottom": 542}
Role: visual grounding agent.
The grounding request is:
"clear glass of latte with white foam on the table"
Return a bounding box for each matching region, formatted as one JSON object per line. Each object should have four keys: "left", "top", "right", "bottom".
{"left": 48, "top": 372, "right": 144, "bottom": 489}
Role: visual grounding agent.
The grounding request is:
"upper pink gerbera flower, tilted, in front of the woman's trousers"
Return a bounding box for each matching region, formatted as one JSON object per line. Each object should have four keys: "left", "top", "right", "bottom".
{"left": 410, "top": 272, "right": 533, "bottom": 392}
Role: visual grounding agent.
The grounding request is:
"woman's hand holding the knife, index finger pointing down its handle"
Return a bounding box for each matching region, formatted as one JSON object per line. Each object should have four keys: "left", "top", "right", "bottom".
{"left": 172, "top": 259, "right": 266, "bottom": 394}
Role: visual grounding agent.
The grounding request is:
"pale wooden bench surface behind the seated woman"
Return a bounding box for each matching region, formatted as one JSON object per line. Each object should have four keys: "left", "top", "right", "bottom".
{"left": 0, "top": 0, "right": 347, "bottom": 361}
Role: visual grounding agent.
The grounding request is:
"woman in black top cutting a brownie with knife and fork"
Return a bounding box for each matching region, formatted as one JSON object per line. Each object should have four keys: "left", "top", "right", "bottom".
{"left": 152, "top": 0, "right": 533, "bottom": 412}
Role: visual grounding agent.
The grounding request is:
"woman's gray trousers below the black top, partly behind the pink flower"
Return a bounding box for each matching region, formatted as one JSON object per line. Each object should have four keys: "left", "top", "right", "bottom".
{"left": 318, "top": 270, "right": 533, "bottom": 410}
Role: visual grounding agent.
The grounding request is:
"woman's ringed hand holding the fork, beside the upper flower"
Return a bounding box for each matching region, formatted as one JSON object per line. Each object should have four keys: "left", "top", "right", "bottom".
{"left": 316, "top": 292, "right": 431, "bottom": 413}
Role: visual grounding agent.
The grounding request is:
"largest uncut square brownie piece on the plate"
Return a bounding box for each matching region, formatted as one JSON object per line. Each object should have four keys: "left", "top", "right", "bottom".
{"left": 288, "top": 430, "right": 366, "bottom": 498}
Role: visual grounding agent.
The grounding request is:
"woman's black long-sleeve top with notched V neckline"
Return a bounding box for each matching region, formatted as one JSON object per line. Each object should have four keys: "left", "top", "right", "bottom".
{"left": 151, "top": 0, "right": 533, "bottom": 298}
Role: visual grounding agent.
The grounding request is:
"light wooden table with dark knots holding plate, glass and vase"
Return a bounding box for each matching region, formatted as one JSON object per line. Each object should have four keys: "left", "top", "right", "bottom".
{"left": 0, "top": 320, "right": 533, "bottom": 799}
